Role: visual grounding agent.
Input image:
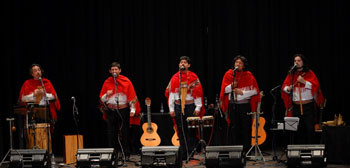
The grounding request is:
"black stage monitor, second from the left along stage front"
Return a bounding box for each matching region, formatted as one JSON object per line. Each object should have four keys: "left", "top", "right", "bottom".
{"left": 76, "top": 148, "right": 117, "bottom": 168}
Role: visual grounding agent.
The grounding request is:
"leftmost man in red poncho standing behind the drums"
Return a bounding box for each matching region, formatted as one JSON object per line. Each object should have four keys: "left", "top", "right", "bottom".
{"left": 18, "top": 64, "right": 61, "bottom": 148}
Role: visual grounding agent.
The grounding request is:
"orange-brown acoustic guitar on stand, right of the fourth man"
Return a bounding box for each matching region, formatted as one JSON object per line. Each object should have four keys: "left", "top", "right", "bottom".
{"left": 251, "top": 91, "right": 266, "bottom": 145}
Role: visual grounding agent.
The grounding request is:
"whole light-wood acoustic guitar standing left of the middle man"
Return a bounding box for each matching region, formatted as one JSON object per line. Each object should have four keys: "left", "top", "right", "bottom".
{"left": 140, "top": 97, "right": 160, "bottom": 146}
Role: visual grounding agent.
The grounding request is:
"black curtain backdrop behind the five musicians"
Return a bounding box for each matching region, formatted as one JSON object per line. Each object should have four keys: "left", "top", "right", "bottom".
{"left": 0, "top": 0, "right": 350, "bottom": 155}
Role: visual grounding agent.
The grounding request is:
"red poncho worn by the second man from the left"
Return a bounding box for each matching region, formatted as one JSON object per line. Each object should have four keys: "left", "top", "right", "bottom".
{"left": 100, "top": 75, "right": 141, "bottom": 125}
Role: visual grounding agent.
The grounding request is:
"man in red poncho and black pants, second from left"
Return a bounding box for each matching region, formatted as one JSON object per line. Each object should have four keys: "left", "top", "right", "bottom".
{"left": 100, "top": 62, "right": 141, "bottom": 161}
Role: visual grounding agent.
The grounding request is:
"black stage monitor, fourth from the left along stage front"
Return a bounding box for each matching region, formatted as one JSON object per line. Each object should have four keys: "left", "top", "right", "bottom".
{"left": 205, "top": 145, "right": 245, "bottom": 167}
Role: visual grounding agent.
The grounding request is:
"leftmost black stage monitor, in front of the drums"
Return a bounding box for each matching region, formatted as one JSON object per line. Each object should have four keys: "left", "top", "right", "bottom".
{"left": 9, "top": 149, "right": 50, "bottom": 168}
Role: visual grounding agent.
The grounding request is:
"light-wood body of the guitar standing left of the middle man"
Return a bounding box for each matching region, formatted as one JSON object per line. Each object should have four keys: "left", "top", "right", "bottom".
{"left": 140, "top": 123, "right": 160, "bottom": 146}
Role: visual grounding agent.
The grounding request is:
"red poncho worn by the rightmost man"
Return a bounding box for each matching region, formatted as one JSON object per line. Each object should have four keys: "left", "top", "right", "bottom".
{"left": 281, "top": 70, "right": 324, "bottom": 117}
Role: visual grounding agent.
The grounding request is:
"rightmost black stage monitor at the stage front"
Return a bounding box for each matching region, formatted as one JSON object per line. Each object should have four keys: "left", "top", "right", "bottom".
{"left": 287, "top": 144, "right": 327, "bottom": 168}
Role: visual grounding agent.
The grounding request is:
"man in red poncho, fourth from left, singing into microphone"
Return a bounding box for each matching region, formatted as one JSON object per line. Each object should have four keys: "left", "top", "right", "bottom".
{"left": 220, "top": 55, "right": 260, "bottom": 152}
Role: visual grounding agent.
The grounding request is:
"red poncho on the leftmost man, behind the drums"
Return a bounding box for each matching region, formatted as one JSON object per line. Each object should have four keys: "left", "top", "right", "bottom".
{"left": 18, "top": 78, "right": 61, "bottom": 120}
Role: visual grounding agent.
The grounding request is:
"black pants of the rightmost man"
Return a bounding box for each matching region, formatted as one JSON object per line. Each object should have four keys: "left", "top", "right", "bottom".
{"left": 293, "top": 102, "right": 315, "bottom": 144}
